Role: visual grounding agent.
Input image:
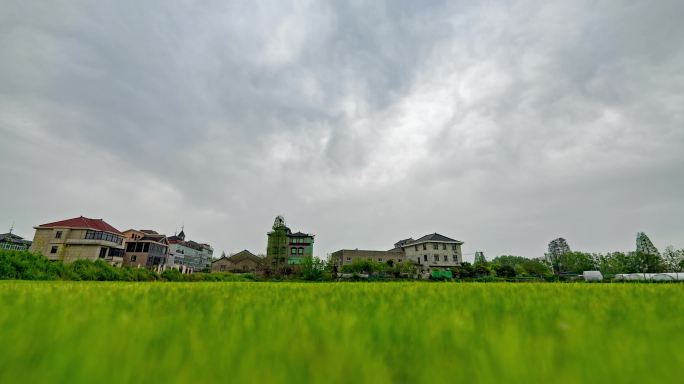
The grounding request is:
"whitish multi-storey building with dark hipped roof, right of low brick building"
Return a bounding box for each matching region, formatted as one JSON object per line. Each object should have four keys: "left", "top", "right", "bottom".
{"left": 401, "top": 233, "right": 463, "bottom": 274}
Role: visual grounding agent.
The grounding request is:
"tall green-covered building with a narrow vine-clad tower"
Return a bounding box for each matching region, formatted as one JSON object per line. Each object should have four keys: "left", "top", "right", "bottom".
{"left": 266, "top": 216, "right": 314, "bottom": 266}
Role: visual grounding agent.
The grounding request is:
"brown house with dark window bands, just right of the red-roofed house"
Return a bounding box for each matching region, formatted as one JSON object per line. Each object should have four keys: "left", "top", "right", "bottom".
{"left": 123, "top": 229, "right": 169, "bottom": 269}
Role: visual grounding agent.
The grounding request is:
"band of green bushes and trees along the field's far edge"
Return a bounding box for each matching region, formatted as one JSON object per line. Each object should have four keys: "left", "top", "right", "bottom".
{"left": 5, "top": 247, "right": 684, "bottom": 282}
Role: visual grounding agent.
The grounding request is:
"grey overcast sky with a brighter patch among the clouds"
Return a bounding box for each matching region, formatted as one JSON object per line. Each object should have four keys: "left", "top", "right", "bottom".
{"left": 0, "top": 0, "right": 684, "bottom": 260}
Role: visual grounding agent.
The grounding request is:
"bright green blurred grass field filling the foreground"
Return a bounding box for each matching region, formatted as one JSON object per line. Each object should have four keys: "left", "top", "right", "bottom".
{"left": 0, "top": 281, "right": 684, "bottom": 383}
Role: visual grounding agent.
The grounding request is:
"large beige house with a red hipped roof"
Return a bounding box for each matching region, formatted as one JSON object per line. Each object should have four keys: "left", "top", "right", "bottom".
{"left": 29, "top": 216, "right": 124, "bottom": 266}
